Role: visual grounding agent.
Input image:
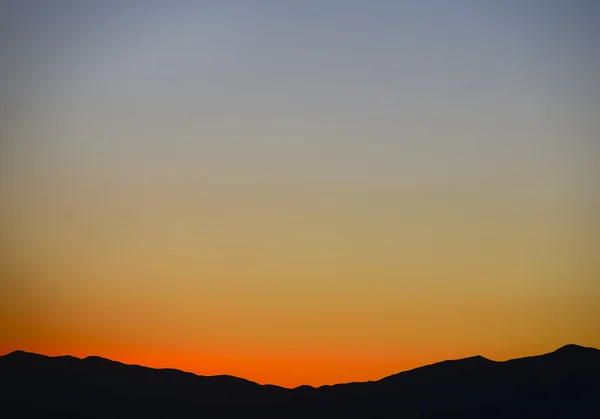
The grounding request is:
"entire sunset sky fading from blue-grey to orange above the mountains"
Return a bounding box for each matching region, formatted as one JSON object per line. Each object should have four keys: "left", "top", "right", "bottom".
{"left": 0, "top": 0, "right": 600, "bottom": 387}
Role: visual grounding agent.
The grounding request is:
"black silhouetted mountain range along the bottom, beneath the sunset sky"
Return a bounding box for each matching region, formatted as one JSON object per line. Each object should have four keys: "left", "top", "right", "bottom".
{"left": 0, "top": 345, "right": 600, "bottom": 419}
